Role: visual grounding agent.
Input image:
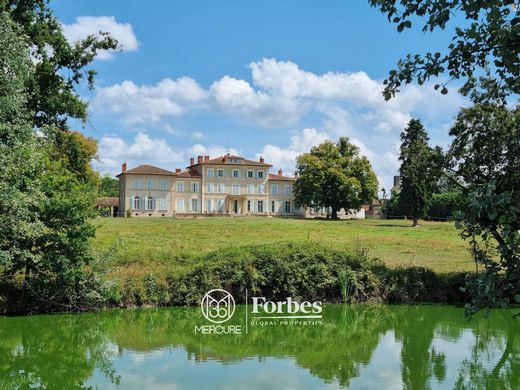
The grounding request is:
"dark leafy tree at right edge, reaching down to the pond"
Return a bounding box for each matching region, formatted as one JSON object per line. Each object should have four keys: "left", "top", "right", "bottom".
{"left": 449, "top": 77, "right": 520, "bottom": 313}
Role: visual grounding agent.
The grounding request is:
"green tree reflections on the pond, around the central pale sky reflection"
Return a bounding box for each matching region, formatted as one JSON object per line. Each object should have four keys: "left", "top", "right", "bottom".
{"left": 0, "top": 305, "right": 520, "bottom": 389}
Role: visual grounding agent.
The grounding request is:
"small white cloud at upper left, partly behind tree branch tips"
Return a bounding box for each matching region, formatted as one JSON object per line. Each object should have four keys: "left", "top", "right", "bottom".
{"left": 62, "top": 16, "right": 139, "bottom": 60}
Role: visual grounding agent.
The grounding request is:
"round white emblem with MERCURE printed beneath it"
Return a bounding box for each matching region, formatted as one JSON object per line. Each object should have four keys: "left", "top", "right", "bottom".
{"left": 195, "top": 288, "right": 242, "bottom": 334}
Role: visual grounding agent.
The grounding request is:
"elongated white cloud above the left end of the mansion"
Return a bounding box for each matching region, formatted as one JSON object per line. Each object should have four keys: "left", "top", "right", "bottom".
{"left": 93, "top": 77, "right": 207, "bottom": 123}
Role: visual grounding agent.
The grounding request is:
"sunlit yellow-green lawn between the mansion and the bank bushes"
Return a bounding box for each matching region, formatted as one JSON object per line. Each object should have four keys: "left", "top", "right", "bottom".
{"left": 94, "top": 217, "right": 474, "bottom": 272}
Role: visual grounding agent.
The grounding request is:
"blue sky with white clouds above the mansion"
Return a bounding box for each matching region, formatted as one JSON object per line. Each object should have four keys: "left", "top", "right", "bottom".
{"left": 50, "top": 0, "right": 465, "bottom": 189}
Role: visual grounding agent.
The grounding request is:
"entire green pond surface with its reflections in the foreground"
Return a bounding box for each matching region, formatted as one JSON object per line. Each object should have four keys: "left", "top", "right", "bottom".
{"left": 0, "top": 305, "right": 520, "bottom": 390}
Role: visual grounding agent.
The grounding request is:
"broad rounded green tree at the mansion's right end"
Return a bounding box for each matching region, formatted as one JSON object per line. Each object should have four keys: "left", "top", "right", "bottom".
{"left": 294, "top": 137, "right": 378, "bottom": 219}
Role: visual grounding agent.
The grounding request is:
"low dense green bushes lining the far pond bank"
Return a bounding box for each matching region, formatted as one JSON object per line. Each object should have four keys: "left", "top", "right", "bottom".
{"left": 106, "top": 242, "right": 464, "bottom": 306}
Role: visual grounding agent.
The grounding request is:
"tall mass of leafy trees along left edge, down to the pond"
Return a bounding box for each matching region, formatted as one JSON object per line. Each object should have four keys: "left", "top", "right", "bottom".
{"left": 0, "top": 1, "right": 116, "bottom": 311}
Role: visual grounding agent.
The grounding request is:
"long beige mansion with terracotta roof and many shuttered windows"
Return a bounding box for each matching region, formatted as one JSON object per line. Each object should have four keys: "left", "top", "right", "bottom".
{"left": 117, "top": 154, "right": 304, "bottom": 217}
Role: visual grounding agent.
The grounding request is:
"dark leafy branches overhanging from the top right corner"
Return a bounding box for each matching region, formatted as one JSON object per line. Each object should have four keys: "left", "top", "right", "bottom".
{"left": 369, "top": 0, "right": 520, "bottom": 100}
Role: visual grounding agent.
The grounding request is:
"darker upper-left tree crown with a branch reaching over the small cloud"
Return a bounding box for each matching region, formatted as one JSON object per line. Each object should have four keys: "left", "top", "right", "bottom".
{"left": 0, "top": 0, "right": 118, "bottom": 131}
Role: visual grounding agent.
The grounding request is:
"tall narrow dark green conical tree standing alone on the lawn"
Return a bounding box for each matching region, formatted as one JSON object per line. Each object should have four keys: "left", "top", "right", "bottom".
{"left": 399, "top": 119, "right": 442, "bottom": 227}
